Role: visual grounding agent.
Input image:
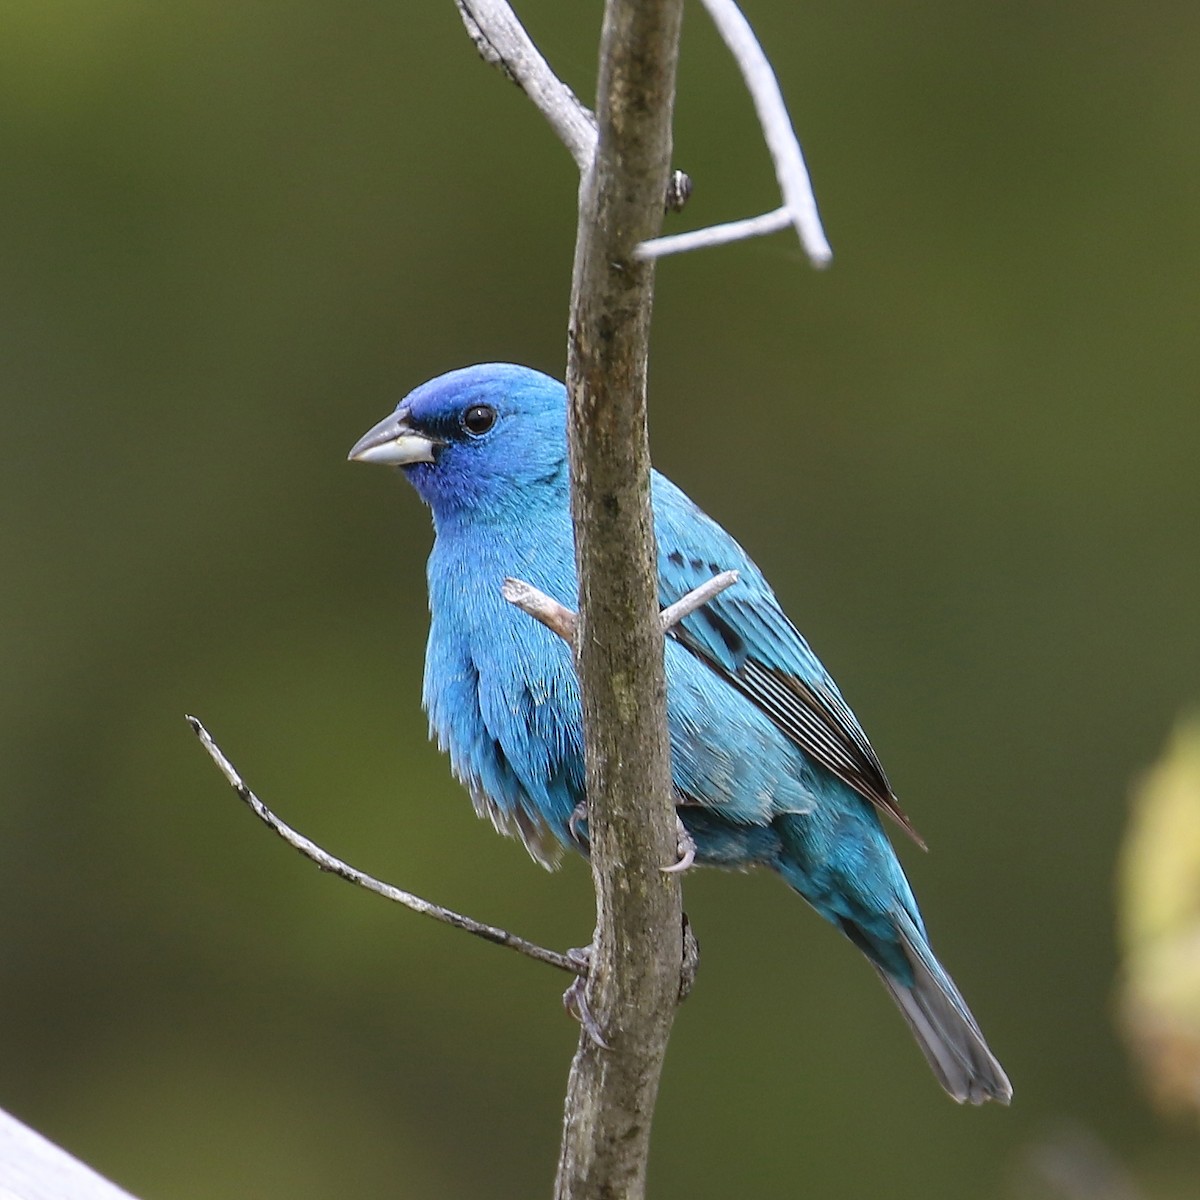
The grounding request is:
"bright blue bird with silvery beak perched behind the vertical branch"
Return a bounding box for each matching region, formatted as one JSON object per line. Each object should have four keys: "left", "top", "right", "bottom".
{"left": 350, "top": 364, "right": 1013, "bottom": 1104}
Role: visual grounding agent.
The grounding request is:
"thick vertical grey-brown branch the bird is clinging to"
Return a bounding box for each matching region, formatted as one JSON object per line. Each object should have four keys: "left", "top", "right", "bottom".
{"left": 556, "top": 0, "right": 683, "bottom": 1200}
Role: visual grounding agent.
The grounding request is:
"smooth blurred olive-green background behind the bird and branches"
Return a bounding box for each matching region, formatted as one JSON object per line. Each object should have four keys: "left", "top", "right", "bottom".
{"left": 0, "top": 0, "right": 1200, "bottom": 1200}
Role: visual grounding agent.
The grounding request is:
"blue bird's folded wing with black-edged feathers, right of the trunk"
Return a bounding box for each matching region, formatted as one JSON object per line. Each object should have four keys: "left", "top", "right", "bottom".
{"left": 654, "top": 475, "right": 925, "bottom": 846}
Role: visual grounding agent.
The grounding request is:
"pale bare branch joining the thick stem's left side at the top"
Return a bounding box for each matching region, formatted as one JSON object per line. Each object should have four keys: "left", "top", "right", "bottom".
{"left": 455, "top": 0, "right": 596, "bottom": 175}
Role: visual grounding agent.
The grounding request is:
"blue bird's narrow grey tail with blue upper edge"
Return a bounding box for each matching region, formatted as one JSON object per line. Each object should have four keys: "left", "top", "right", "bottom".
{"left": 871, "top": 912, "right": 1013, "bottom": 1104}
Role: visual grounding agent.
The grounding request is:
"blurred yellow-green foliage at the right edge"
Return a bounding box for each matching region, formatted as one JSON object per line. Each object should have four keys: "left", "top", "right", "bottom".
{"left": 1120, "top": 716, "right": 1200, "bottom": 1116}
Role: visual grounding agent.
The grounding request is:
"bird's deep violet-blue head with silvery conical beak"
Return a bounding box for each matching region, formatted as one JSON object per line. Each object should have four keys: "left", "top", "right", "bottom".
{"left": 349, "top": 362, "right": 566, "bottom": 518}
